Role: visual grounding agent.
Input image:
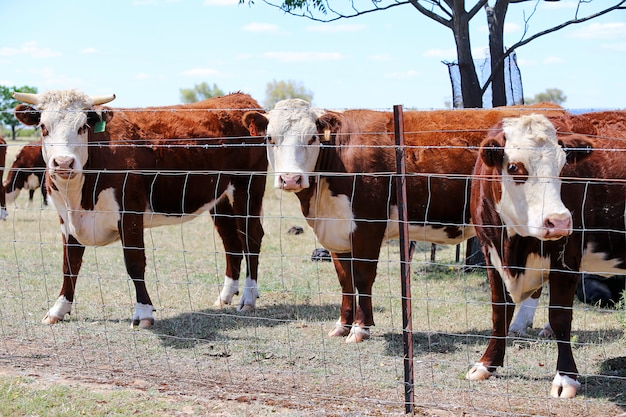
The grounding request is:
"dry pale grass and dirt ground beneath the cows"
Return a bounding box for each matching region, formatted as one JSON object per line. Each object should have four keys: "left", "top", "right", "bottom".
{"left": 0, "top": 136, "right": 626, "bottom": 416}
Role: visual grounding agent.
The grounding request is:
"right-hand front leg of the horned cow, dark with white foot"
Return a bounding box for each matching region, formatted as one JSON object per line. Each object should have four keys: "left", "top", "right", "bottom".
{"left": 119, "top": 210, "right": 155, "bottom": 329}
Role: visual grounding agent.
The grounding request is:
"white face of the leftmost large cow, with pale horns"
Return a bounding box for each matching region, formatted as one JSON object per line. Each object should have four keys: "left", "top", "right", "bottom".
{"left": 14, "top": 90, "right": 115, "bottom": 180}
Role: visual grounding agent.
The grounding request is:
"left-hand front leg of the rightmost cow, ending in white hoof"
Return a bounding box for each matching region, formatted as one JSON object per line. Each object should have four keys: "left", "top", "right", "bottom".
{"left": 465, "top": 266, "right": 515, "bottom": 381}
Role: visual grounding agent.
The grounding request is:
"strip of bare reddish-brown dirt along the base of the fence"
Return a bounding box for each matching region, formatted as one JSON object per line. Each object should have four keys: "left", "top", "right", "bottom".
{"left": 0, "top": 339, "right": 626, "bottom": 417}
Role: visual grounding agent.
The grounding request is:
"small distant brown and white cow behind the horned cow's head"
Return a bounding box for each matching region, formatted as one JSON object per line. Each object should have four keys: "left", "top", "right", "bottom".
{"left": 3, "top": 141, "right": 48, "bottom": 205}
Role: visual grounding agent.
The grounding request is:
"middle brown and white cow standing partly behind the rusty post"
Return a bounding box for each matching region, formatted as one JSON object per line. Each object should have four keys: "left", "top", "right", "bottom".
{"left": 244, "top": 99, "right": 564, "bottom": 342}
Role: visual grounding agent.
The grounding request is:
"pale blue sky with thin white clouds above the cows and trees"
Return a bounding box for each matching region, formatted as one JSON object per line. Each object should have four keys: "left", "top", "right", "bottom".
{"left": 0, "top": 0, "right": 626, "bottom": 109}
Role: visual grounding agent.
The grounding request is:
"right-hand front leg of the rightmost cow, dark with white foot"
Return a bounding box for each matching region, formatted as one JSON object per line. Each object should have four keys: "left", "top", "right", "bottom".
{"left": 549, "top": 272, "right": 580, "bottom": 398}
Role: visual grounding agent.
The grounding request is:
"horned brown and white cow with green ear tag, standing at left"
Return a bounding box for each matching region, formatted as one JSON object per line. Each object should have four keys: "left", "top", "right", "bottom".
{"left": 15, "top": 90, "right": 267, "bottom": 327}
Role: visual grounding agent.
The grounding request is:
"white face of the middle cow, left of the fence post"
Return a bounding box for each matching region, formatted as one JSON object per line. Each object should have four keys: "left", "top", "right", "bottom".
{"left": 244, "top": 99, "right": 324, "bottom": 193}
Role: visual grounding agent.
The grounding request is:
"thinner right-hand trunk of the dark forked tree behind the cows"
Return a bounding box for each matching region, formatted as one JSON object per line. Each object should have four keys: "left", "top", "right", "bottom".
{"left": 485, "top": 0, "right": 509, "bottom": 107}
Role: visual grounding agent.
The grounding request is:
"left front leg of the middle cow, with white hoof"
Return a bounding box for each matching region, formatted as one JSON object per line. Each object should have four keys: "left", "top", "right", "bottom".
{"left": 328, "top": 252, "right": 356, "bottom": 337}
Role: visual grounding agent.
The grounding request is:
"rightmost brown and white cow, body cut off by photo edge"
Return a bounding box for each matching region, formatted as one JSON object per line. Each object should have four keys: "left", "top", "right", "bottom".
{"left": 467, "top": 116, "right": 626, "bottom": 398}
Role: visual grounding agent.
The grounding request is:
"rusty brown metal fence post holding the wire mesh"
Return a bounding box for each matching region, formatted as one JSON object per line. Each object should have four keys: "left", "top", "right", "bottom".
{"left": 393, "top": 105, "right": 415, "bottom": 414}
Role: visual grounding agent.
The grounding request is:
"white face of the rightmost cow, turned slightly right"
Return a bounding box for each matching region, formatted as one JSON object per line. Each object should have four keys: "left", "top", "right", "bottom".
{"left": 481, "top": 115, "right": 572, "bottom": 240}
